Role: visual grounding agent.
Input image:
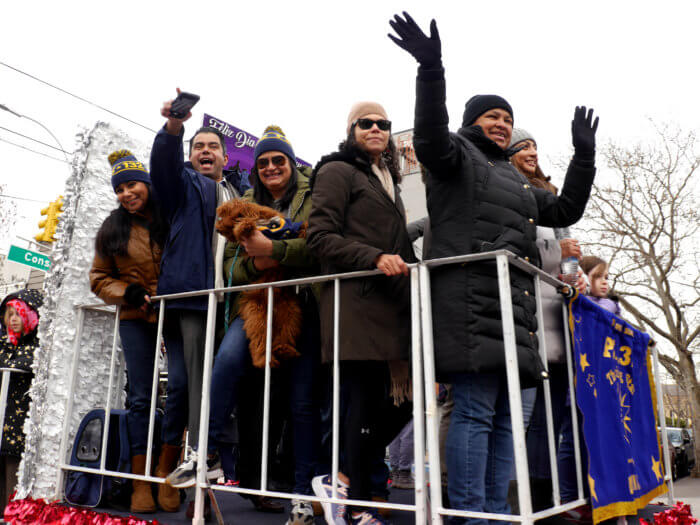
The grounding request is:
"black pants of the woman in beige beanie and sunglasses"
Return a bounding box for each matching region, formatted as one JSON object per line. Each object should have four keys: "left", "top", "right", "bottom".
{"left": 340, "top": 361, "right": 418, "bottom": 506}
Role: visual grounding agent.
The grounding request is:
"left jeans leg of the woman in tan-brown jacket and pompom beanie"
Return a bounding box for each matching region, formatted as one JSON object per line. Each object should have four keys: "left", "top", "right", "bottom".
{"left": 119, "top": 319, "right": 157, "bottom": 456}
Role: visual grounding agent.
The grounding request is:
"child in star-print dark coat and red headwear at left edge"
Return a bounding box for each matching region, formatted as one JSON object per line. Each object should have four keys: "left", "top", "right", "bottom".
{"left": 0, "top": 290, "right": 43, "bottom": 508}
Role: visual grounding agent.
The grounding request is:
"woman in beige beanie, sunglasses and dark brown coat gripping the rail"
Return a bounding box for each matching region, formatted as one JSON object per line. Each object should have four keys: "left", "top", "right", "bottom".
{"left": 307, "top": 102, "right": 415, "bottom": 524}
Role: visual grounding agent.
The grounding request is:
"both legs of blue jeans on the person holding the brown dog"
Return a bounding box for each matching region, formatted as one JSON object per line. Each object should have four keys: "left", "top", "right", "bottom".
{"left": 209, "top": 301, "right": 321, "bottom": 494}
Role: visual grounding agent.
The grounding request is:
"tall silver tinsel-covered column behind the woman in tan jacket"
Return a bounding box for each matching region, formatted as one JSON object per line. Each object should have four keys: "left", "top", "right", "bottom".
{"left": 17, "top": 122, "right": 149, "bottom": 500}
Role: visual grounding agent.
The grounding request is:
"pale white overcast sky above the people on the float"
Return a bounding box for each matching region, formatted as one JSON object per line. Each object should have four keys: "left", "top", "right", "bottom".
{"left": 0, "top": 0, "right": 700, "bottom": 253}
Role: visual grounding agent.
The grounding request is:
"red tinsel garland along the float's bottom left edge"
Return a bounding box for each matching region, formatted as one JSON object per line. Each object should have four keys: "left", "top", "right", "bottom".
{"left": 3, "top": 498, "right": 160, "bottom": 525}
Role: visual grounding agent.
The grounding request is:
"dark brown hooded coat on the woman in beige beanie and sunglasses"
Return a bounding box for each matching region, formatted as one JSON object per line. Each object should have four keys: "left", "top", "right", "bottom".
{"left": 307, "top": 146, "right": 415, "bottom": 362}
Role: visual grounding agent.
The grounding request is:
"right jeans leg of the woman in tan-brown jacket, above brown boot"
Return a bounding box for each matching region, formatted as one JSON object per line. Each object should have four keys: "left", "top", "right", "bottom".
{"left": 161, "top": 310, "right": 189, "bottom": 446}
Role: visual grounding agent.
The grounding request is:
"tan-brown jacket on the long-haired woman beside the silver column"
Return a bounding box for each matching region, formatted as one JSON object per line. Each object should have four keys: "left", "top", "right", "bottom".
{"left": 90, "top": 222, "right": 161, "bottom": 322}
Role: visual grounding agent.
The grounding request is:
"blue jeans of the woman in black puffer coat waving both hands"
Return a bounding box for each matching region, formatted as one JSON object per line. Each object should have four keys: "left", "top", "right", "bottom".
{"left": 446, "top": 373, "right": 513, "bottom": 524}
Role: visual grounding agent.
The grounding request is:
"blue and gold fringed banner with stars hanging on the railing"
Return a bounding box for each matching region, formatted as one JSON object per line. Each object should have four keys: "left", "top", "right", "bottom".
{"left": 569, "top": 295, "right": 666, "bottom": 523}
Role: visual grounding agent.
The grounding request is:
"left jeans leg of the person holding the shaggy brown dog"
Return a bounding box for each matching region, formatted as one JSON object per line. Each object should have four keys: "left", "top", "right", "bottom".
{"left": 209, "top": 317, "right": 253, "bottom": 452}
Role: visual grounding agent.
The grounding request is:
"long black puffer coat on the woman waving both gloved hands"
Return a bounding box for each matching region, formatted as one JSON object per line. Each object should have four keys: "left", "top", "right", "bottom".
{"left": 413, "top": 69, "right": 595, "bottom": 385}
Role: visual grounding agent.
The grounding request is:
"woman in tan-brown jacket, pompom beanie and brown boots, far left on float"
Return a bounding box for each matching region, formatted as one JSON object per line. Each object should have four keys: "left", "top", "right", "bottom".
{"left": 90, "top": 150, "right": 186, "bottom": 513}
